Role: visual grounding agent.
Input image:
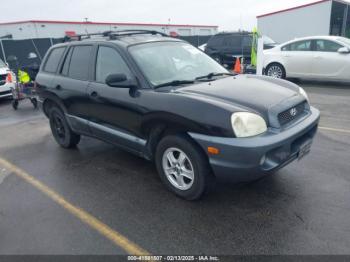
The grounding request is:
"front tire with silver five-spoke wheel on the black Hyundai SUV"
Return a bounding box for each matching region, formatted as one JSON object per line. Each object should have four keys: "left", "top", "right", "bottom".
{"left": 155, "top": 135, "right": 211, "bottom": 200}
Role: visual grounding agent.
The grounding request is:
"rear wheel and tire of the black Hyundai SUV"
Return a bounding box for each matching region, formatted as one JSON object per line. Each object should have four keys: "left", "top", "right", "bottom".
{"left": 50, "top": 107, "right": 80, "bottom": 148}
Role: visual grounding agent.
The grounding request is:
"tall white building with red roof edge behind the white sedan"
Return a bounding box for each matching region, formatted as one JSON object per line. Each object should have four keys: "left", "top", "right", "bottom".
{"left": 257, "top": 0, "right": 350, "bottom": 43}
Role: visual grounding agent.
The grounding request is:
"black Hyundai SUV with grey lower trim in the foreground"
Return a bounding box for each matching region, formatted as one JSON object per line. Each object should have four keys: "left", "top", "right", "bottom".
{"left": 36, "top": 31, "right": 319, "bottom": 200}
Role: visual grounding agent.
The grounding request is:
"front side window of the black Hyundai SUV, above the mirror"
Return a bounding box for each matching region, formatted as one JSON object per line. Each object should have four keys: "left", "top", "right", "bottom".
{"left": 96, "top": 46, "right": 130, "bottom": 83}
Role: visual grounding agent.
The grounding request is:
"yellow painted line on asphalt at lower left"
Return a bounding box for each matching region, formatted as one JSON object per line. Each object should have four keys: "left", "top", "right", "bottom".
{"left": 0, "top": 158, "right": 150, "bottom": 256}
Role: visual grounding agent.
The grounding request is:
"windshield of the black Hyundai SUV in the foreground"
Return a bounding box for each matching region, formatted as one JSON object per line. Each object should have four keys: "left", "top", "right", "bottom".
{"left": 130, "top": 42, "right": 228, "bottom": 86}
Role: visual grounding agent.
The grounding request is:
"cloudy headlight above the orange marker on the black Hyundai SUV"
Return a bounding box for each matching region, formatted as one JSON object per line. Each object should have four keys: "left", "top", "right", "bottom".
{"left": 231, "top": 112, "right": 267, "bottom": 137}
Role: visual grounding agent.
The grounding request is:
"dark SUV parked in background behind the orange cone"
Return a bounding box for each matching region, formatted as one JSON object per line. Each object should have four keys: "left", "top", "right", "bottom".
{"left": 205, "top": 31, "right": 277, "bottom": 67}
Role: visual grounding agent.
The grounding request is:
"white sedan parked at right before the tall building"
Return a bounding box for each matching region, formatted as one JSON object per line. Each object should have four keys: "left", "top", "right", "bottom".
{"left": 264, "top": 36, "right": 350, "bottom": 81}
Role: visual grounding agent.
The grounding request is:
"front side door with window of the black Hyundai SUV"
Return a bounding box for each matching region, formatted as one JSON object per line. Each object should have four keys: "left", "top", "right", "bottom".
{"left": 88, "top": 44, "right": 144, "bottom": 154}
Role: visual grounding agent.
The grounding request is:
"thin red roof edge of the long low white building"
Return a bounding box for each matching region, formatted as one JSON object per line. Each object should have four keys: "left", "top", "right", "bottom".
{"left": 0, "top": 20, "right": 219, "bottom": 28}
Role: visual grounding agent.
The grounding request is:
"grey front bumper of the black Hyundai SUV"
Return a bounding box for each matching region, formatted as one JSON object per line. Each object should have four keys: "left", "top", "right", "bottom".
{"left": 189, "top": 107, "right": 320, "bottom": 182}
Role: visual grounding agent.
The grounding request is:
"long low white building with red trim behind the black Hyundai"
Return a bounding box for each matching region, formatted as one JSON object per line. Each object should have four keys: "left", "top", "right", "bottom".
{"left": 0, "top": 20, "right": 218, "bottom": 39}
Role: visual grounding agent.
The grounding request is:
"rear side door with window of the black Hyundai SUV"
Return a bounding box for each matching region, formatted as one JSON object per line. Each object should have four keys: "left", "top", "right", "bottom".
{"left": 53, "top": 45, "right": 93, "bottom": 134}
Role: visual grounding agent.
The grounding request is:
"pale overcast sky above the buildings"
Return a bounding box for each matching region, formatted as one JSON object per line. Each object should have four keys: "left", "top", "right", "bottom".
{"left": 0, "top": 0, "right": 344, "bottom": 30}
